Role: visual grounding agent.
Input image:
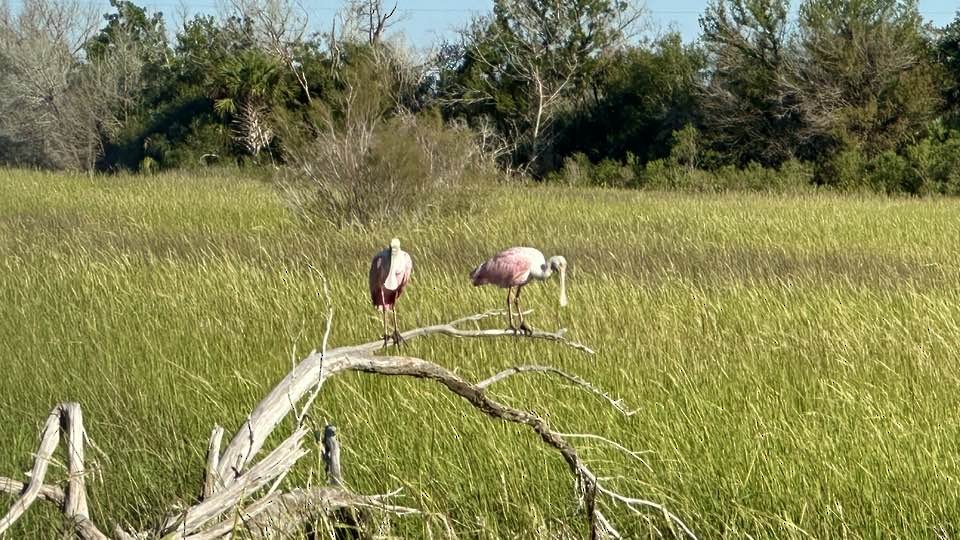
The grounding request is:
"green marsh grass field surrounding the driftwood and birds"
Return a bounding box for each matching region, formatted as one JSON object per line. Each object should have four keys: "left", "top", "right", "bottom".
{"left": 0, "top": 171, "right": 960, "bottom": 538}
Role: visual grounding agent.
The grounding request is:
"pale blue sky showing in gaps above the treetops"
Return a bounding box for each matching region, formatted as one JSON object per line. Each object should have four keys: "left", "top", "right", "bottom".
{"left": 22, "top": 0, "right": 960, "bottom": 47}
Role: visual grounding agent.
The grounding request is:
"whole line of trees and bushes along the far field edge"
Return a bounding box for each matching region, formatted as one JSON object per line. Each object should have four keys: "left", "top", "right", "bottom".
{"left": 0, "top": 0, "right": 960, "bottom": 197}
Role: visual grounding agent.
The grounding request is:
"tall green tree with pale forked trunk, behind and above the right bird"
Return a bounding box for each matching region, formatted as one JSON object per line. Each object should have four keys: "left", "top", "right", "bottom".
{"left": 441, "top": 0, "right": 639, "bottom": 173}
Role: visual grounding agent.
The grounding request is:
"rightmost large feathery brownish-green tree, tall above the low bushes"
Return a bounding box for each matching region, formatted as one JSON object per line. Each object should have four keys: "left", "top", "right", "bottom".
{"left": 789, "top": 0, "right": 940, "bottom": 157}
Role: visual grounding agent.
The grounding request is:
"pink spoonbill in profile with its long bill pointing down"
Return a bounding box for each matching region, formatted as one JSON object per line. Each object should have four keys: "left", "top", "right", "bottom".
{"left": 470, "top": 247, "right": 567, "bottom": 335}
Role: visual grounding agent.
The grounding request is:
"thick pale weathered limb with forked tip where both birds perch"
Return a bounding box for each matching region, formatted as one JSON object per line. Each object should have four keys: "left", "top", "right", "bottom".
{"left": 220, "top": 311, "right": 593, "bottom": 486}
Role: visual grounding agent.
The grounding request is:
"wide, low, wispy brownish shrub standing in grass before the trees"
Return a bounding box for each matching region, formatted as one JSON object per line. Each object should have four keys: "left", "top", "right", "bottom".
{"left": 279, "top": 110, "right": 485, "bottom": 225}
